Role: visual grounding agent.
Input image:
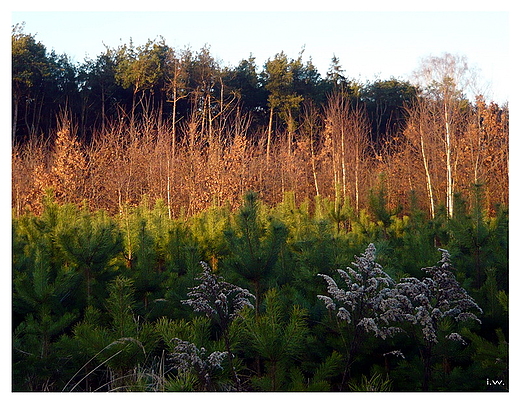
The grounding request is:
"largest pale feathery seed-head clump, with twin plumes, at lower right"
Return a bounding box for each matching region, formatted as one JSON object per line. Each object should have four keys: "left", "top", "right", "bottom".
{"left": 318, "top": 244, "right": 482, "bottom": 390}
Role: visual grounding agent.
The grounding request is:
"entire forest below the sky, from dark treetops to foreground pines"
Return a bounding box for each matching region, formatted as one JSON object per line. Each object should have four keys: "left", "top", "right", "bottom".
{"left": 11, "top": 24, "right": 509, "bottom": 392}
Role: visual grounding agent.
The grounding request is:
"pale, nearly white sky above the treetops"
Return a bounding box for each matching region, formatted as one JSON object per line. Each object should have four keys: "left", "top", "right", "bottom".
{"left": 11, "top": 0, "right": 510, "bottom": 104}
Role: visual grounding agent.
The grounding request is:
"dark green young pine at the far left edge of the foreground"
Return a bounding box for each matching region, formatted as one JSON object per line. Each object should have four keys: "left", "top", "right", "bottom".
{"left": 13, "top": 234, "right": 78, "bottom": 391}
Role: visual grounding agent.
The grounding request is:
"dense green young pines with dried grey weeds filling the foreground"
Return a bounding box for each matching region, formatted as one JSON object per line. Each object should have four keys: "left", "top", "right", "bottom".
{"left": 12, "top": 187, "right": 509, "bottom": 391}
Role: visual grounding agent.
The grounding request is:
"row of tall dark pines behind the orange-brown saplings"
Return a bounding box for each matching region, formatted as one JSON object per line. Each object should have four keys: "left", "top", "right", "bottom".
{"left": 12, "top": 24, "right": 415, "bottom": 147}
